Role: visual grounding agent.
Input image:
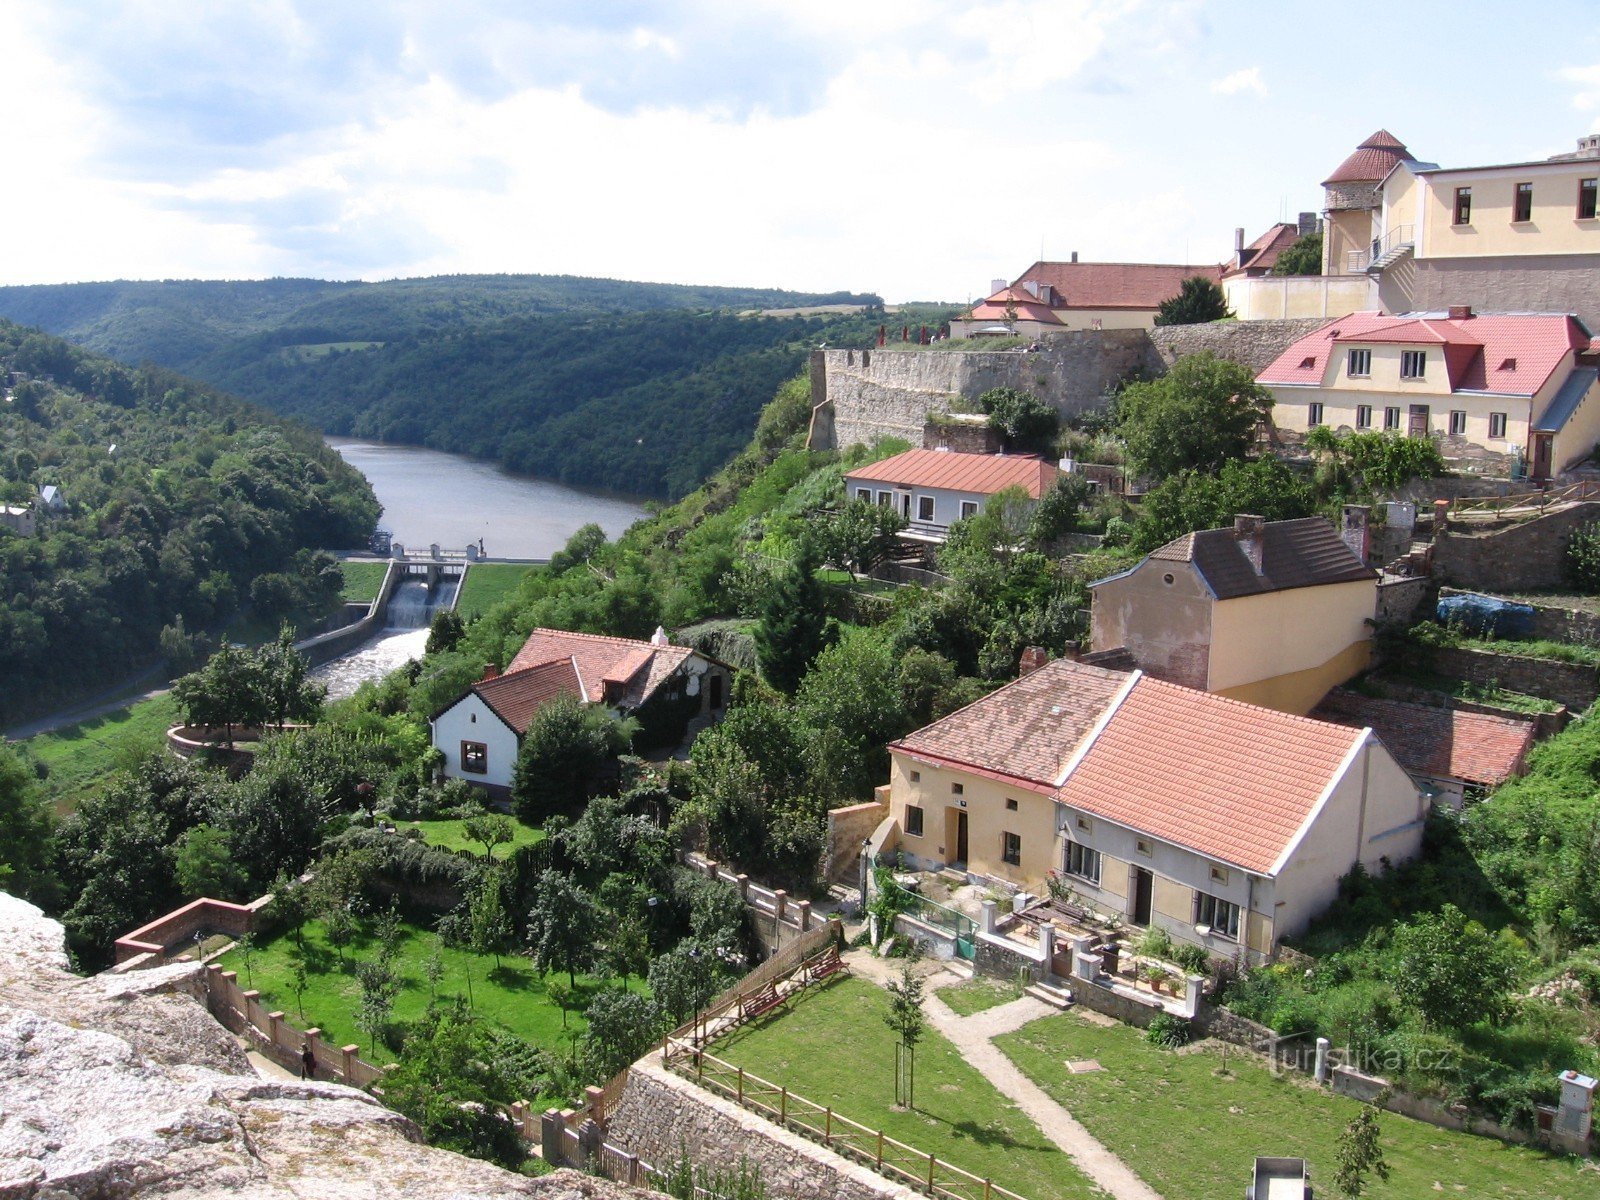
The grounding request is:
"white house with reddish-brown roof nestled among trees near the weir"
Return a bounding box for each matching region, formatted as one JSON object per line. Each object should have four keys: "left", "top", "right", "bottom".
{"left": 429, "top": 629, "right": 731, "bottom": 795}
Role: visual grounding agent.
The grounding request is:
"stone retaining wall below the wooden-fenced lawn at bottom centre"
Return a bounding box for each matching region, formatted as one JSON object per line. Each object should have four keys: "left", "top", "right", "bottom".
{"left": 605, "top": 1054, "right": 915, "bottom": 1200}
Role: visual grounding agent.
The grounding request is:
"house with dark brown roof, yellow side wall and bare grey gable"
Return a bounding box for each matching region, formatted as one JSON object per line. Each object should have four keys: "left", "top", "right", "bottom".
{"left": 1090, "top": 515, "right": 1378, "bottom": 714}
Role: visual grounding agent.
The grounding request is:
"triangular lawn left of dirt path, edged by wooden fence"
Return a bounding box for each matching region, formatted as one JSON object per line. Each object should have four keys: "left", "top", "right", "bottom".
{"left": 710, "top": 979, "right": 1094, "bottom": 1200}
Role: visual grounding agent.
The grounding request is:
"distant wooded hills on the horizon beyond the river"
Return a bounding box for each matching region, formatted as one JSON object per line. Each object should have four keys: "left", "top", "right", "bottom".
{"left": 0, "top": 275, "right": 949, "bottom": 498}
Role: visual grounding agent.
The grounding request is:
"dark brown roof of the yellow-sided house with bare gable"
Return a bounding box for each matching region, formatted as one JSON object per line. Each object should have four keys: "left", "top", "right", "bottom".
{"left": 1120, "top": 517, "right": 1378, "bottom": 600}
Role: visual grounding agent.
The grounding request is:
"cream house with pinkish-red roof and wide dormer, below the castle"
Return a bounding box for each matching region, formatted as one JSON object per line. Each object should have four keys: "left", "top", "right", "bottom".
{"left": 1256, "top": 306, "right": 1600, "bottom": 482}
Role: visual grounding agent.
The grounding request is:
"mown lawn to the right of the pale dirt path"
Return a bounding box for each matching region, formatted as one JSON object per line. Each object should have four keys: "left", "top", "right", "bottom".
{"left": 995, "top": 1014, "right": 1600, "bottom": 1200}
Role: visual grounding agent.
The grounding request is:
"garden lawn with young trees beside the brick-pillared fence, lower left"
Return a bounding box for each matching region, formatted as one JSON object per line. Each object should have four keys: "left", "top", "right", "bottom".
{"left": 221, "top": 922, "right": 642, "bottom": 1068}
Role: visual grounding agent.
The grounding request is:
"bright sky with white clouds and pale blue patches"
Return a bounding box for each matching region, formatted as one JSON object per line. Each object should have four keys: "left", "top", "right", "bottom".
{"left": 9, "top": 0, "right": 1600, "bottom": 302}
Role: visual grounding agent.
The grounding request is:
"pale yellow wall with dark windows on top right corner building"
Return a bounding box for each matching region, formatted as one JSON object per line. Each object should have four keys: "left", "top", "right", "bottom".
{"left": 1420, "top": 158, "right": 1600, "bottom": 258}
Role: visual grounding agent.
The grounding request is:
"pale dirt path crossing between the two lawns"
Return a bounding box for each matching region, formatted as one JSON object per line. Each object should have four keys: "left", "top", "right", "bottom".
{"left": 848, "top": 950, "right": 1162, "bottom": 1200}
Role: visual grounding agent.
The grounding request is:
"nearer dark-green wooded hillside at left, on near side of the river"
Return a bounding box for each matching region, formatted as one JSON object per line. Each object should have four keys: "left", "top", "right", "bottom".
{"left": 0, "top": 320, "right": 378, "bottom": 723}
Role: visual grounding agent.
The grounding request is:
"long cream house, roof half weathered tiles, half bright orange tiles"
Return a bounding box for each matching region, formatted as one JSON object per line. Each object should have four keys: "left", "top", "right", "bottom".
{"left": 890, "top": 661, "right": 1427, "bottom": 962}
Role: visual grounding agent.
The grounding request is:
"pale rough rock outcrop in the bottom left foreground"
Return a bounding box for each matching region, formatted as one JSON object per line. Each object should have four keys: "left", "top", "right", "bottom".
{"left": 0, "top": 893, "right": 656, "bottom": 1200}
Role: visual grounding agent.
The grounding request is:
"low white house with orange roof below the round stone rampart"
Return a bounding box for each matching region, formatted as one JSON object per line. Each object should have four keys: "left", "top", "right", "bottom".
{"left": 845, "top": 450, "right": 1061, "bottom": 541}
